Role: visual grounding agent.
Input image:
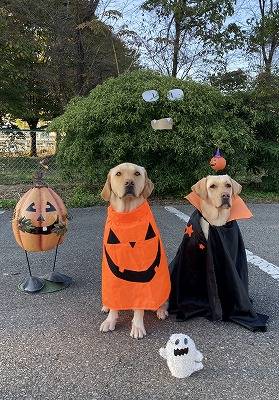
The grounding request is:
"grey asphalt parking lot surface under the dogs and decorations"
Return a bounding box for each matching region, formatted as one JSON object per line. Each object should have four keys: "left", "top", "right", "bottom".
{"left": 0, "top": 204, "right": 279, "bottom": 400}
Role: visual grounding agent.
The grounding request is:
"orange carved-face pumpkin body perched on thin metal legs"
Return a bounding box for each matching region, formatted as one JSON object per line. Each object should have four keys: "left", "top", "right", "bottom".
{"left": 12, "top": 186, "right": 67, "bottom": 252}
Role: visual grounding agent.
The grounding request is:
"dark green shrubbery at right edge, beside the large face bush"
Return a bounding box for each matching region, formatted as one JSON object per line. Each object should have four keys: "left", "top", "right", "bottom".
{"left": 230, "top": 77, "right": 279, "bottom": 192}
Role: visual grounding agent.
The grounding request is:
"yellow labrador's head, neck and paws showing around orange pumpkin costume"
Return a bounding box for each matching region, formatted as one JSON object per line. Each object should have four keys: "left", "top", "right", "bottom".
{"left": 100, "top": 163, "right": 168, "bottom": 339}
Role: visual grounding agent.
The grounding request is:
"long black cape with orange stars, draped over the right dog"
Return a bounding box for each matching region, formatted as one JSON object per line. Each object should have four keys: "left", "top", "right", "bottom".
{"left": 169, "top": 210, "right": 268, "bottom": 332}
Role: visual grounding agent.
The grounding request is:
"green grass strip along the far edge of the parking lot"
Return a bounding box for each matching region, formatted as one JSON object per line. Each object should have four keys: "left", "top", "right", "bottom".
{"left": 0, "top": 157, "right": 279, "bottom": 208}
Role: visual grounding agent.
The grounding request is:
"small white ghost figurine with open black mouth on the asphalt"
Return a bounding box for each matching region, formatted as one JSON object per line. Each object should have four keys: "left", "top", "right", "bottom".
{"left": 159, "top": 333, "right": 203, "bottom": 378}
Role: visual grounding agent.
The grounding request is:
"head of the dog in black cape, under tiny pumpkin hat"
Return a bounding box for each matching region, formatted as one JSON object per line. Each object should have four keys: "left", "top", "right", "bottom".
{"left": 192, "top": 175, "right": 242, "bottom": 208}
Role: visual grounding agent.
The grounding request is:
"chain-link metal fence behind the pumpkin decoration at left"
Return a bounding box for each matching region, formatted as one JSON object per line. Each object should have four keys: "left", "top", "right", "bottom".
{"left": 0, "top": 129, "right": 96, "bottom": 208}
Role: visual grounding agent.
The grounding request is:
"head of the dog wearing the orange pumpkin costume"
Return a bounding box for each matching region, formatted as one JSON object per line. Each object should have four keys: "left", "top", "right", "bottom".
{"left": 101, "top": 163, "right": 154, "bottom": 201}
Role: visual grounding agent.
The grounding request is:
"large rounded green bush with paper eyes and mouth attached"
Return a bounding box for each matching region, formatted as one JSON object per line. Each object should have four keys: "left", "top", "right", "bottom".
{"left": 50, "top": 71, "right": 262, "bottom": 195}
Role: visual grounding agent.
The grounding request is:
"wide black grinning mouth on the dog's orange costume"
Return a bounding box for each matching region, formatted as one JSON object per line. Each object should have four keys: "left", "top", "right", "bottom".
{"left": 105, "top": 240, "right": 161, "bottom": 283}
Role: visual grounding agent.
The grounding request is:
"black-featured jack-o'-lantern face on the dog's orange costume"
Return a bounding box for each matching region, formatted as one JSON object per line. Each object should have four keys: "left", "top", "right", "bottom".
{"left": 105, "top": 223, "right": 161, "bottom": 283}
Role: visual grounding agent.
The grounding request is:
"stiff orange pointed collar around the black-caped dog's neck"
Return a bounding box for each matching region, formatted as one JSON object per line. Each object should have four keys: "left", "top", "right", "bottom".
{"left": 185, "top": 192, "right": 253, "bottom": 222}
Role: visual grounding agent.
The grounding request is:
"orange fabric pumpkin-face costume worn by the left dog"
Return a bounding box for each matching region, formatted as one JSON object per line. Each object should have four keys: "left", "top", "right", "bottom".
{"left": 102, "top": 201, "right": 170, "bottom": 310}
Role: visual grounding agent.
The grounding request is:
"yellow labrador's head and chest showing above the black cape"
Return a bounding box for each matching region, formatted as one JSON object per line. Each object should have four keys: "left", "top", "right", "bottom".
{"left": 192, "top": 175, "right": 242, "bottom": 239}
